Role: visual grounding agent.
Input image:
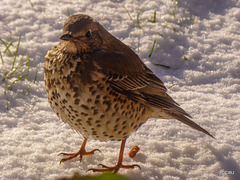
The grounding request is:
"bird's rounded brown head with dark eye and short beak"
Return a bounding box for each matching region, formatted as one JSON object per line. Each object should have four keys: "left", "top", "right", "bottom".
{"left": 60, "top": 14, "right": 107, "bottom": 53}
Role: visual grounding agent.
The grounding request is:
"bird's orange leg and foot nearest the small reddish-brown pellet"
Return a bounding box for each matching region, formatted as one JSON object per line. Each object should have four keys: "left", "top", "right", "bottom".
{"left": 88, "top": 139, "right": 141, "bottom": 173}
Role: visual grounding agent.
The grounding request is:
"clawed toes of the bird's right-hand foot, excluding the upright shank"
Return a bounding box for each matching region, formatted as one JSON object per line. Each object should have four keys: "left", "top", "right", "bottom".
{"left": 87, "top": 164, "right": 141, "bottom": 173}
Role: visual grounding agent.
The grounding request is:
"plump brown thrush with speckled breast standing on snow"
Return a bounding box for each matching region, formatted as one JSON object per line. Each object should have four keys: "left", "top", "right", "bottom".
{"left": 44, "top": 14, "right": 214, "bottom": 173}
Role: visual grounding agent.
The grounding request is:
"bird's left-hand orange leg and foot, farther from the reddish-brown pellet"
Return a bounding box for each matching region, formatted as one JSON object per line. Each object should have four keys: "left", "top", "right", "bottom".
{"left": 59, "top": 138, "right": 101, "bottom": 164}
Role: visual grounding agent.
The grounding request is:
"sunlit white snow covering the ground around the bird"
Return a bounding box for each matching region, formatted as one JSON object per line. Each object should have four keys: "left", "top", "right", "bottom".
{"left": 0, "top": 0, "right": 240, "bottom": 179}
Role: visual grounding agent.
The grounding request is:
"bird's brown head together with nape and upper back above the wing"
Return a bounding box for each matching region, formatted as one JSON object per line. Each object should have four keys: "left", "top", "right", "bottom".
{"left": 60, "top": 14, "right": 136, "bottom": 56}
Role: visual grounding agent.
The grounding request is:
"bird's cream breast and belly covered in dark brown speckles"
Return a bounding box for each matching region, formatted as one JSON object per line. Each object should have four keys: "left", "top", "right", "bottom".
{"left": 44, "top": 43, "right": 149, "bottom": 141}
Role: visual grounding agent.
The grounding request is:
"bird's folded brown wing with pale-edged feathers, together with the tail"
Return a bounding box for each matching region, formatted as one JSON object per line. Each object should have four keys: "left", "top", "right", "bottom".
{"left": 89, "top": 50, "right": 213, "bottom": 137}
